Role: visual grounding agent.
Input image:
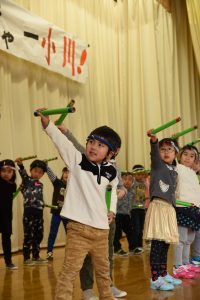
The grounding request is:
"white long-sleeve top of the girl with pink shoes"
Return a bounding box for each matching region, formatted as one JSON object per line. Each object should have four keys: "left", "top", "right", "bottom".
{"left": 177, "top": 164, "right": 200, "bottom": 206}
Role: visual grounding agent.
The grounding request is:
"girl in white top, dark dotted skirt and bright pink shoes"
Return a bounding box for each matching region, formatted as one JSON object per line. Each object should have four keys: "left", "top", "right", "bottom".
{"left": 173, "top": 145, "right": 200, "bottom": 278}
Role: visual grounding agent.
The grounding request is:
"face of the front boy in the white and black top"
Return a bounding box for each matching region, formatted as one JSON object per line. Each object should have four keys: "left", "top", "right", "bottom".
{"left": 86, "top": 139, "right": 109, "bottom": 164}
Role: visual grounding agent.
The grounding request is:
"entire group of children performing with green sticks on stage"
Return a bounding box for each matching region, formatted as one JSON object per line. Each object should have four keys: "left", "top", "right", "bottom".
{"left": 0, "top": 113, "right": 200, "bottom": 300}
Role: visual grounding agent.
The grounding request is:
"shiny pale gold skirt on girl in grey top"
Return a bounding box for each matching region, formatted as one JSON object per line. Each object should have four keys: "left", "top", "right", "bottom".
{"left": 143, "top": 198, "right": 179, "bottom": 244}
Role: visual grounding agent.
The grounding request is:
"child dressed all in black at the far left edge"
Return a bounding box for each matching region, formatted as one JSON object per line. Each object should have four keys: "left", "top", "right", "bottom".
{"left": 0, "top": 159, "right": 17, "bottom": 270}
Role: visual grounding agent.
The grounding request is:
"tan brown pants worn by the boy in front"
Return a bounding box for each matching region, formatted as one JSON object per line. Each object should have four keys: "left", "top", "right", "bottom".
{"left": 55, "top": 221, "right": 114, "bottom": 300}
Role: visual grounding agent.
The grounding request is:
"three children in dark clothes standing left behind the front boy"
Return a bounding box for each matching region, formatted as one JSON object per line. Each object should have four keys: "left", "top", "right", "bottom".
{"left": 0, "top": 158, "right": 69, "bottom": 270}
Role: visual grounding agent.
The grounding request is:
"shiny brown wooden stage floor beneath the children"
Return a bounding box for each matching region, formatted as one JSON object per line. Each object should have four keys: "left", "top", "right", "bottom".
{"left": 0, "top": 247, "right": 200, "bottom": 300}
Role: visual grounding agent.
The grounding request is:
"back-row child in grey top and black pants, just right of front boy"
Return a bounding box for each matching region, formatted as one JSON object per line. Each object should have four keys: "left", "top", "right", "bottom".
{"left": 114, "top": 172, "right": 134, "bottom": 256}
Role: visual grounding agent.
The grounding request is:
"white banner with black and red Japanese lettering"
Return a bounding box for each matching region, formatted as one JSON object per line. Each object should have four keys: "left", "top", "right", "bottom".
{"left": 0, "top": 0, "right": 88, "bottom": 82}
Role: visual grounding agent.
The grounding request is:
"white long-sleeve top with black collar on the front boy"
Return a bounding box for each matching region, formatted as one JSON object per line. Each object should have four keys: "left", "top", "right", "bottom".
{"left": 45, "top": 122, "right": 118, "bottom": 229}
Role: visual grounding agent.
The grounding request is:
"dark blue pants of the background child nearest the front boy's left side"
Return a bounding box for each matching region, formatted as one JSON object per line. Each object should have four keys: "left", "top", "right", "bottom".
{"left": 47, "top": 214, "right": 68, "bottom": 252}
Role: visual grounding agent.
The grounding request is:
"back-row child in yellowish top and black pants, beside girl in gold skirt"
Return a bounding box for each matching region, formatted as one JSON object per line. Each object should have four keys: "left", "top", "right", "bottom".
{"left": 131, "top": 165, "right": 147, "bottom": 254}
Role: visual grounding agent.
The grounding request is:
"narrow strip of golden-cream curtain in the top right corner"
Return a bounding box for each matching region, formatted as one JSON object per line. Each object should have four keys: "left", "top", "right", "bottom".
{"left": 186, "top": 0, "right": 200, "bottom": 74}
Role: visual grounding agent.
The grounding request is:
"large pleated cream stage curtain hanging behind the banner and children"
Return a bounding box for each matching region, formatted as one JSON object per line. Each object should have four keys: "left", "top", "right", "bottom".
{"left": 0, "top": 0, "right": 200, "bottom": 250}
